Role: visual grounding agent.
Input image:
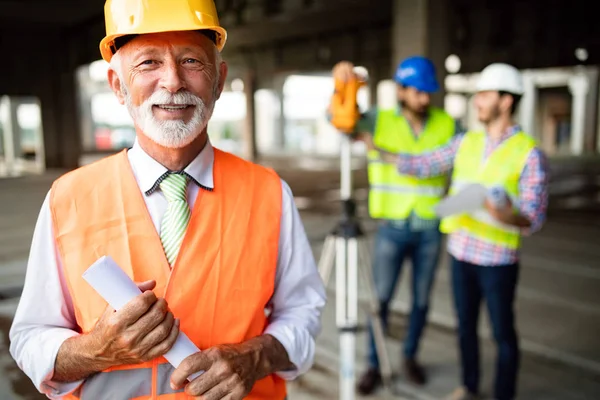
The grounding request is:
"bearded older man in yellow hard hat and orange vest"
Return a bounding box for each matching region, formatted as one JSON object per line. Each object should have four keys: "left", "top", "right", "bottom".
{"left": 10, "top": 0, "right": 325, "bottom": 400}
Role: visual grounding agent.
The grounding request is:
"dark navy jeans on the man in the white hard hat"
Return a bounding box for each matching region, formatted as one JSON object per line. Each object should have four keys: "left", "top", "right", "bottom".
{"left": 452, "top": 257, "right": 519, "bottom": 400}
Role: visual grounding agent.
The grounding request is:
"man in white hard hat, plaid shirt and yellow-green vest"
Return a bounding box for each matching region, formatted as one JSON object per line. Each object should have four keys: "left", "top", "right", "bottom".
{"left": 363, "top": 64, "right": 548, "bottom": 400}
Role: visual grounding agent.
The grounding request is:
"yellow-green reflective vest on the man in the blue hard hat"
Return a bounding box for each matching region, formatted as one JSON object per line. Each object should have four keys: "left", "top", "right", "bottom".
{"left": 368, "top": 108, "right": 456, "bottom": 220}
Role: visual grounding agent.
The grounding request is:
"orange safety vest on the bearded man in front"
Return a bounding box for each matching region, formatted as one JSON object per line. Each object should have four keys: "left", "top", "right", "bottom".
{"left": 50, "top": 149, "right": 286, "bottom": 400}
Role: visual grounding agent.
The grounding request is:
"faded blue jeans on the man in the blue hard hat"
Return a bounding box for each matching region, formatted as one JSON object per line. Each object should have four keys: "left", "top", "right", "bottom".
{"left": 368, "top": 221, "right": 442, "bottom": 368}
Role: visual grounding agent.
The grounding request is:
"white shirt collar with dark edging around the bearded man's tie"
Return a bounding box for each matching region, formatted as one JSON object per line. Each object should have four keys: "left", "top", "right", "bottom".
{"left": 128, "top": 139, "right": 215, "bottom": 195}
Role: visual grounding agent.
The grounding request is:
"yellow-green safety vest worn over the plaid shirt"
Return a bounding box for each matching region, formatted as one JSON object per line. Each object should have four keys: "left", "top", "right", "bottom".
{"left": 440, "top": 132, "right": 536, "bottom": 249}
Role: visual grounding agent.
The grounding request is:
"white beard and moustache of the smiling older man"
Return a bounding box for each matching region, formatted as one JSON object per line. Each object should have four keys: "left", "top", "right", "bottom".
{"left": 121, "top": 84, "right": 215, "bottom": 149}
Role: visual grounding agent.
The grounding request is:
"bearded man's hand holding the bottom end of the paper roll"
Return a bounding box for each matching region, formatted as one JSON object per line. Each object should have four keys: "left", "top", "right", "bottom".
{"left": 171, "top": 343, "right": 260, "bottom": 400}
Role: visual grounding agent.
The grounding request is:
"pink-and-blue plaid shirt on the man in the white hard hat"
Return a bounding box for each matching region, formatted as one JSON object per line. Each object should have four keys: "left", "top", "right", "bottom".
{"left": 398, "top": 126, "right": 548, "bottom": 266}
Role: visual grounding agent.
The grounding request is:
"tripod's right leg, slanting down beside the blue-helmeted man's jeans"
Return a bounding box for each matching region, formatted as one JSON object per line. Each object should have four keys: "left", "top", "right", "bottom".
{"left": 358, "top": 240, "right": 392, "bottom": 389}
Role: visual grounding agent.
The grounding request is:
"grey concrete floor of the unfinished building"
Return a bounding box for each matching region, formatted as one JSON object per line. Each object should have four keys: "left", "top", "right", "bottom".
{"left": 0, "top": 160, "right": 600, "bottom": 400}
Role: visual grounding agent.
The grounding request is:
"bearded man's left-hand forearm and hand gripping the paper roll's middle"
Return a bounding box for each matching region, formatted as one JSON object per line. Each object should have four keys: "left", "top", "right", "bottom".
{"left": 52, "top": 281, "right": 179, "bottom": 382}
